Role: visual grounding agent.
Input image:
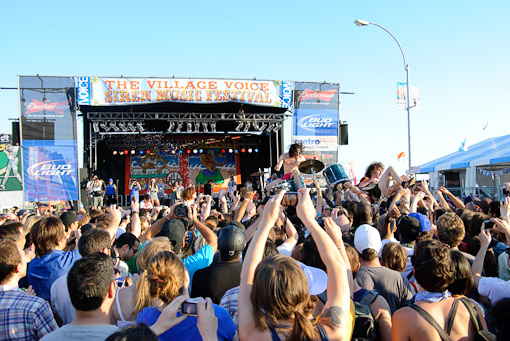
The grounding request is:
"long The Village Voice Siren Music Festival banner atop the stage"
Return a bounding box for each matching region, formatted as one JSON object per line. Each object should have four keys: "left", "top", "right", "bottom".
{"left": 76, "top": 77, "right": 293, "bottom": 109}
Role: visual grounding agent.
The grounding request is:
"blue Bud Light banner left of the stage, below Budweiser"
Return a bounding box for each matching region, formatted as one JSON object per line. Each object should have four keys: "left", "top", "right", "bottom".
{"left": 22, "top": 140, "right": 79, "bottom": 202}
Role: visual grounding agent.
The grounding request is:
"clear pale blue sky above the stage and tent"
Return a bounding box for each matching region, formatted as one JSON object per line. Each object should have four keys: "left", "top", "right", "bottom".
{"left": 0, "top": 0, "right": 510, "bottom": 175}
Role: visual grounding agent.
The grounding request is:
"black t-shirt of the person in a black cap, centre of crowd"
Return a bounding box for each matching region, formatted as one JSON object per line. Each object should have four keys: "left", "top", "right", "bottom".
{"left": 190, "top": 262, "right": 242, "bottom": 304}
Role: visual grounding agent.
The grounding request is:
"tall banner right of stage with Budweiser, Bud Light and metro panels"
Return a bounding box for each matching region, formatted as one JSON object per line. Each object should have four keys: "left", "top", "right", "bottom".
{"left": 292, "top": 82, "right": 340, "bottom": 152}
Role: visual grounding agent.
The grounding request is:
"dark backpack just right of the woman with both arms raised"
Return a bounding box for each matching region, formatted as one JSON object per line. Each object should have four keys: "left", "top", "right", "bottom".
{"left": 351, "top": 290, "right": 379, "bottom": 341}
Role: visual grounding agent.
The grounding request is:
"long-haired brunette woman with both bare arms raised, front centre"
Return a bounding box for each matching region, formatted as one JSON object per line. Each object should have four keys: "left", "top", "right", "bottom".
{"left": 239, "top": 189, "right": 350, "bottom": 340}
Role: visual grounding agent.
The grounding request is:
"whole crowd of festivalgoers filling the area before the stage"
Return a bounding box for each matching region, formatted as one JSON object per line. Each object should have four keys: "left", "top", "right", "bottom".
{"left": 0, "top": 153, "right": 510, "bottom": 340}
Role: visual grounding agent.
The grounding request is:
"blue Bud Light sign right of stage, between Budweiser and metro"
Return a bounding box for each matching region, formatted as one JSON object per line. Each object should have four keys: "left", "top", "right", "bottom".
{"left": 294, "top": 109, "right": 338, "bottom": 136}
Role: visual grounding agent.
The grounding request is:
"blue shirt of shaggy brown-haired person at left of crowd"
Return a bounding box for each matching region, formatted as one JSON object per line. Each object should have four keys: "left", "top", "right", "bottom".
{"left": 27, "top": 250, "right": 81, "bottom": 301}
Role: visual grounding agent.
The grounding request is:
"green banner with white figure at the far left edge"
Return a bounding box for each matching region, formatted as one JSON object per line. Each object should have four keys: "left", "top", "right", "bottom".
{"left": 0, "top": 134, "right": 23, "bottom": 192}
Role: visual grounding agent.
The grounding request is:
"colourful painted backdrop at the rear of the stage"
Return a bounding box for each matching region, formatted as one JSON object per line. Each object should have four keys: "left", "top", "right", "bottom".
{"left": 125, "top": 148, "right": 240, "bottom": 193}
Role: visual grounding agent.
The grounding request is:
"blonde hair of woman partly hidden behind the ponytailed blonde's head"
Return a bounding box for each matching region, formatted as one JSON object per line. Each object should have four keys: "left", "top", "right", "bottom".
{"left": 135, "top": 237, "right": 172, "bottom": 315}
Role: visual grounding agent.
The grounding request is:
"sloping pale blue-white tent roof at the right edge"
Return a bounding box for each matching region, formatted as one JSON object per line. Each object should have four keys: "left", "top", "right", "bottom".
{"left": 415, "top": 135, "right": 510, "bottom": 173}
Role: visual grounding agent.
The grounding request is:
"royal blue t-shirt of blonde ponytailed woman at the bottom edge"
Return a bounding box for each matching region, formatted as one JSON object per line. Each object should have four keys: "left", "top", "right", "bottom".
{"left": 136, "top": 304, "right": 237, "bottom": 341}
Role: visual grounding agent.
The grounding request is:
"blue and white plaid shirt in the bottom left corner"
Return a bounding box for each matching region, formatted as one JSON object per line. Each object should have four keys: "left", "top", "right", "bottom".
{"left": 0, "top": 285, "right": 58, "bottom": 340}
